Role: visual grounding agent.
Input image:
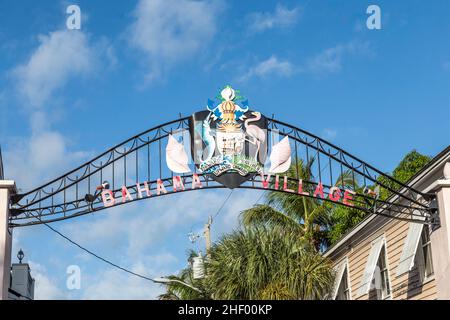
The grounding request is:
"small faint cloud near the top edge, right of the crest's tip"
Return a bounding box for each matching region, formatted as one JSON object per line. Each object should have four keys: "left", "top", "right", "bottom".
{"left": 247, "top": 4, "right": 301, "bottom": 33}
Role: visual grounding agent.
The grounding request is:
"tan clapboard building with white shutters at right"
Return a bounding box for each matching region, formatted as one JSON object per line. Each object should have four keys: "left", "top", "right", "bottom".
{"left": 324, "top": 146, "right": 450, "bottom": 300}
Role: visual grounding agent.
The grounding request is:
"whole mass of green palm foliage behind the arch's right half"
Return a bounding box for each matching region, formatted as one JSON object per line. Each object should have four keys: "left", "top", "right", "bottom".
{"left": 160, "top": 150, "right": 431, "bottom": 300}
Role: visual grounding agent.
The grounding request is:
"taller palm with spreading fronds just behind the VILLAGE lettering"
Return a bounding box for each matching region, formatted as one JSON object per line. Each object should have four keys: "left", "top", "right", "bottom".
{"left": 241, "top": 158, "right": 353, "bottom": 250}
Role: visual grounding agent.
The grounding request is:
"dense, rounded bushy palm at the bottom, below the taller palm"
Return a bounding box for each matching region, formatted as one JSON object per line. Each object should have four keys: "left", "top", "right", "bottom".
{"left": 207, "top": 226, "right": 334, "bottom": 300}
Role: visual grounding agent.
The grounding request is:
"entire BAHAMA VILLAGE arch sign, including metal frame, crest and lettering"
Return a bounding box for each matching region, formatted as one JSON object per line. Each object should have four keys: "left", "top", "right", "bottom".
{"left": 10, "top": 86, "right": 433, "bottom": 227}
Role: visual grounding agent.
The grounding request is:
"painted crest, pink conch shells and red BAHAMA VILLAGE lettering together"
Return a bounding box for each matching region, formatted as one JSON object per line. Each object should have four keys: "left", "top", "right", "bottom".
{"left": 99, "top": 86, "right": 355, "bottom": 207}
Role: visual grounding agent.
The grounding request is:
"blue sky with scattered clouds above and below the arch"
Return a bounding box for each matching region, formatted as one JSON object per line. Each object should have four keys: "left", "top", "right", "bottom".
{"left": 0, "top": 0, "right": 450, "bottom": 299}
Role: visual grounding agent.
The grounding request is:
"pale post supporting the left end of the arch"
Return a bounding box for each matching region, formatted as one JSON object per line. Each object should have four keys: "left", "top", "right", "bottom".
{"left": 0, "top": 180, "right": 17, "bottom": 300}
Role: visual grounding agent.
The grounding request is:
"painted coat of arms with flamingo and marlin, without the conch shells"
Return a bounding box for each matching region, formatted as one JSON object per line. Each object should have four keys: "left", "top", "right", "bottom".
{"left": 189, "top": 87, "right": 267, "bottom": 189}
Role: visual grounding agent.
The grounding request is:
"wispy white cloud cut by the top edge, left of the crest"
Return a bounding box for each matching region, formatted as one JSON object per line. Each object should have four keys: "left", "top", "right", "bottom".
{"left": 127, "top": 0, "right": 220, "bottom": 81}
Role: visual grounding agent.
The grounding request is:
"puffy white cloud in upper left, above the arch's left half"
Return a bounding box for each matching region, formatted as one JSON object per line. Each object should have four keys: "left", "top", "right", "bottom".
{"left": 13, "top": 30, "right": 97, "bottom": 107}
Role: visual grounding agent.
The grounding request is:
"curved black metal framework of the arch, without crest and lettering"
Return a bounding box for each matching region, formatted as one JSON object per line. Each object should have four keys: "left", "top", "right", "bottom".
{"left": 10, "top": 117, "right": 433, "bottom": 227}
